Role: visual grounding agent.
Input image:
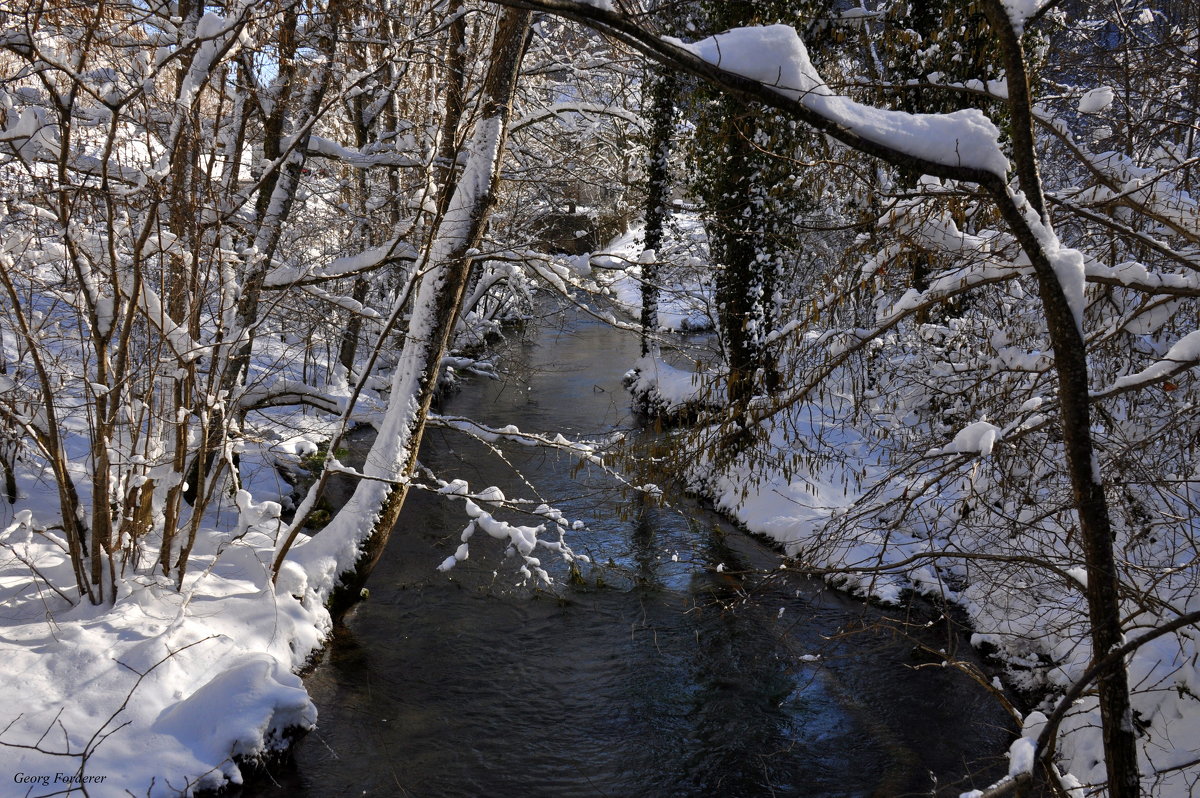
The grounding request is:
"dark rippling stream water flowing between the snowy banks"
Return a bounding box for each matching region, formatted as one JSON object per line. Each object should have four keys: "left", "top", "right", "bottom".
{"left": 250, "top": 307, "right": 1009, "bottom": 798}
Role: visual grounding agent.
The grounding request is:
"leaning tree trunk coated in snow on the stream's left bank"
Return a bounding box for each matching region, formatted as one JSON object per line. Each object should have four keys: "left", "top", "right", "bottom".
{"left": 275, "top": 8, "right": 530, "bottom": 617}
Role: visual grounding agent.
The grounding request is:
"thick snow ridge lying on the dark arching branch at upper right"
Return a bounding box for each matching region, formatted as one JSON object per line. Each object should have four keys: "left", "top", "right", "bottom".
{"left": 666, "top": 25, "right": 1009, "bottom": 178}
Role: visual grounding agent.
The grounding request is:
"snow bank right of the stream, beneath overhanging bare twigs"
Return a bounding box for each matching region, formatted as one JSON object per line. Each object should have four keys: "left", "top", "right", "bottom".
{"left": 683, "top": 376, "right": 1200, "bottom": 798}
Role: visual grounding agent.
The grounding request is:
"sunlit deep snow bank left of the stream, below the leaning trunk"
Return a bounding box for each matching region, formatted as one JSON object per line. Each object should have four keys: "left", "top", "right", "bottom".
{"left": 0, "top": 494, "right": 330, "bottom": 798}
